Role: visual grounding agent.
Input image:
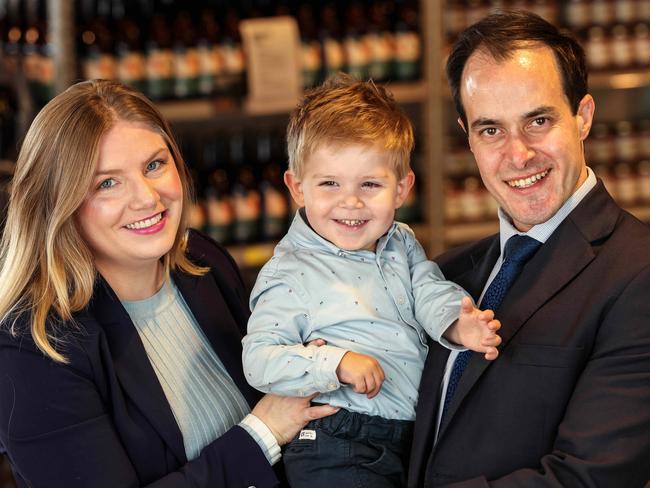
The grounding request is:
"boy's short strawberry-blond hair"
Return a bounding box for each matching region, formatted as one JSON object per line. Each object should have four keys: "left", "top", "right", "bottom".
{"left": 287, "top": 73, "right": 413, "bottom": 180}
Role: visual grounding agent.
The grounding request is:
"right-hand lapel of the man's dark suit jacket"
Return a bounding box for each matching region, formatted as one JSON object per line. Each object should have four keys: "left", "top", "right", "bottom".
{"left": 439, "top": 183, "right": 620, "bottom": 436}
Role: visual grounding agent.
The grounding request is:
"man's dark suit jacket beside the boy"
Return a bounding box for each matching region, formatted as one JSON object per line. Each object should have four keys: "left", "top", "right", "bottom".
{"left": 409, "top": 182, "right": 650, "bottom": 488}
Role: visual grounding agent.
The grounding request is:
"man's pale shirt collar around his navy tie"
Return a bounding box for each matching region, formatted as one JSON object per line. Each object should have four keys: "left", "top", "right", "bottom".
{"left": 499, "top": 167, "right": 596, "bottom": 255}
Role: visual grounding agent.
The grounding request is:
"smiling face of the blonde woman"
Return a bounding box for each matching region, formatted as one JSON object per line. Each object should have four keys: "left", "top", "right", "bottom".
{"left": 77, "top": 121, "right": 183, "bottom": 277}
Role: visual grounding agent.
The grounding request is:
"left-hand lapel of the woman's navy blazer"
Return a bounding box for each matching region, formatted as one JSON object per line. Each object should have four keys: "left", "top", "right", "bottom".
{"left": 89, "top": 277, "right": 187, "bottom": 464}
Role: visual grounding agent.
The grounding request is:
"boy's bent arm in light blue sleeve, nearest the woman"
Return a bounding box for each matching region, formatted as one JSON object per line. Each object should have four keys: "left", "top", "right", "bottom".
{"left": 242, "top": 274, "right": 347, "bottom": 396}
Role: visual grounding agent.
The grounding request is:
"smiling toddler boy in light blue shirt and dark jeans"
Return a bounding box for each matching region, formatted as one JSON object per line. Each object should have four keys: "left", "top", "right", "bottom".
{"left": 243, "top": 75, "right": 500, "bottom": 488}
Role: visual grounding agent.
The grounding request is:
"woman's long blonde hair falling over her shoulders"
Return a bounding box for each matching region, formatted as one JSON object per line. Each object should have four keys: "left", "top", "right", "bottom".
{"left": 0, "top": 80, "right": 205, "bottom": 362}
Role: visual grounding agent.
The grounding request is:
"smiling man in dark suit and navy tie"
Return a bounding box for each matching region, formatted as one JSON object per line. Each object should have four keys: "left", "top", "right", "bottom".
{"left": 409, "top": 12, "right": 650, "bottom": 488}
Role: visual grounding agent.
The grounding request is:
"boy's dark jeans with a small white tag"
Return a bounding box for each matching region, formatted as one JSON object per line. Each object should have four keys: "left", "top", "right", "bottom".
{"left": 282, "top": 409, "right": 413, "bottom": 488}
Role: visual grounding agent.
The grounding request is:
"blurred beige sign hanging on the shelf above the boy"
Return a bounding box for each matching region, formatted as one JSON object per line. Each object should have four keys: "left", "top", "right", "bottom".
{"left": 239, "top": 17, "right": 302, "bottom": 113}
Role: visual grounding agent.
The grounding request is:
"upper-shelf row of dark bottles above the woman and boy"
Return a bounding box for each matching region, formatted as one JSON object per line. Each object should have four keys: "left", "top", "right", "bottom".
{"left": 0, "top": 0, "right": 421, "bottom": 105}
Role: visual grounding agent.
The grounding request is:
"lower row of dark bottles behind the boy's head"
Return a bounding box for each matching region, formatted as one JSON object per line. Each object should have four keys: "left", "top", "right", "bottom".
{"left": 183, "top": 130, "right": 420, "bottom": 244}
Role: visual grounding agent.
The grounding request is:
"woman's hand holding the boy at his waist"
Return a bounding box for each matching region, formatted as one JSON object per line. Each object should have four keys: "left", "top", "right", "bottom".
{"left": 251, "top": 393, "right": 339, "bottom": 446}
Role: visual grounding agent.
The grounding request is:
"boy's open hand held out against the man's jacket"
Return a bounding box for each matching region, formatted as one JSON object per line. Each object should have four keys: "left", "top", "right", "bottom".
{"left": 445, "top": 297, "right": 501, "bottom": 360}
